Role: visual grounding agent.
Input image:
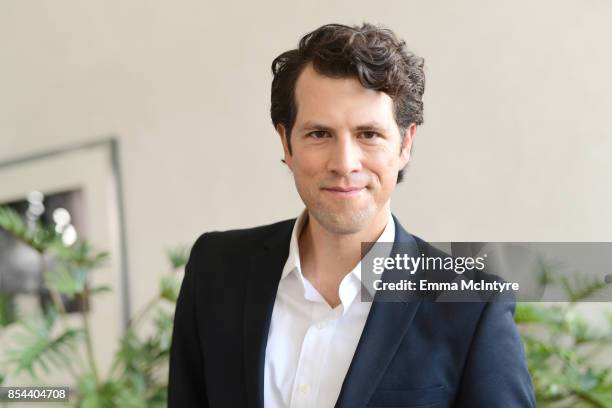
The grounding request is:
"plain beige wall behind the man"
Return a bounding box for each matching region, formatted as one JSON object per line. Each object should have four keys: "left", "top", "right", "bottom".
{"left": 0, "top": 0, "right": 612, "bottom": 352}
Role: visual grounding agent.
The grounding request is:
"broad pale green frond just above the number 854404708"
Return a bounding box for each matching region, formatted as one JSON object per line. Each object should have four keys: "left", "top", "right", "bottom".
{"left": 6, "top": 309, "right": 83, "bottom": 378}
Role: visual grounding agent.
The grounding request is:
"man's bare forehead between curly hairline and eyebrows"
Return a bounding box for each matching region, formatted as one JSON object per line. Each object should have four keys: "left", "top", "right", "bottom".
{"left": 295, "top": 64, "right": 395, "bottom": 126}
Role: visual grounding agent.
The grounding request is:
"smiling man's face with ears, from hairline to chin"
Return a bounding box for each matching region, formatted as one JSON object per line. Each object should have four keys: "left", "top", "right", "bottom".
{"left": 277, "top": 65, "right": 416, "bottom": 234}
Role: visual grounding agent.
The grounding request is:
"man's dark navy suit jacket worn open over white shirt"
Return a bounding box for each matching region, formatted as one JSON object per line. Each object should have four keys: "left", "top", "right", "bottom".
{"left": 168, "top": 217, "right": 535, "bottom": 408}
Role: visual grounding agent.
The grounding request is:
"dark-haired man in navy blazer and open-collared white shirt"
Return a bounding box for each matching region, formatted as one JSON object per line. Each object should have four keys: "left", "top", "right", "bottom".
{"left": 169, "top": 24, "right": 535, "bottom": 408}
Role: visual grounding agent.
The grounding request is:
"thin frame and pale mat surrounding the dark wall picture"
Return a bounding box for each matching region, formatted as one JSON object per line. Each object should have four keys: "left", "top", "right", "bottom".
{"left": 0, "top": 135, "right": 131, "bottom": 370}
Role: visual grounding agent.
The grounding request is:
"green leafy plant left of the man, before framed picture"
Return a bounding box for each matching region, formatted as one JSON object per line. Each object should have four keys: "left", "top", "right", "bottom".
{"left": 0, "top": 207, "right": 189, "bottom": 408}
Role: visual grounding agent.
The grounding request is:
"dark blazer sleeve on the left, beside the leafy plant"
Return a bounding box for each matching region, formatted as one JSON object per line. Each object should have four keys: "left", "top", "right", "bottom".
{"left": 168, "top": 234, "right": 209, "bottom": 408}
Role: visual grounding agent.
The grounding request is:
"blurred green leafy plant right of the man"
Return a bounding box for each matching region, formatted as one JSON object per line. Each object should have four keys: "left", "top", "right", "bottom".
{"left": 515, "top": 258, "right": 612, "bottom": 408}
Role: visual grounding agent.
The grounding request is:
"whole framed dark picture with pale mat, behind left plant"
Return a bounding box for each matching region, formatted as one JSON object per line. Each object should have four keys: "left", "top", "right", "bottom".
{"left": 0, "top": 137, "right": 130, "bottom": 370}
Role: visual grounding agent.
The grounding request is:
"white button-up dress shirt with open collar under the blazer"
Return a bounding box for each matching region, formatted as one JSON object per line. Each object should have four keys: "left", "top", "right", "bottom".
{"left": 264, "top": 210, "right": 395, "bottom": 408}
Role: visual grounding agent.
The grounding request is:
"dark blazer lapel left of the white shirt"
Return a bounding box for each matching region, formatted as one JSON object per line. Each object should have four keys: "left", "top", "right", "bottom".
{"left": 244, "top": 220, "right": 295, "bottom": 408}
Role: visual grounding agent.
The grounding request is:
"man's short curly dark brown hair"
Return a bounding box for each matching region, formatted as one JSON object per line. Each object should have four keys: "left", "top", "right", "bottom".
{"left": 270, "top": 23, "right": 425, "bottom": 183}
